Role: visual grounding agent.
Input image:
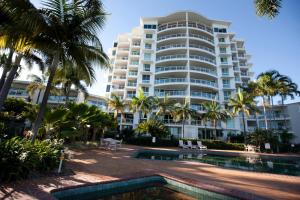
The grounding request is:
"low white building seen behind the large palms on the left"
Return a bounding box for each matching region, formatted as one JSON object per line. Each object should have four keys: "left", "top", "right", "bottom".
{"left": 8, "top": 80, "right": 107, "bottom": 111}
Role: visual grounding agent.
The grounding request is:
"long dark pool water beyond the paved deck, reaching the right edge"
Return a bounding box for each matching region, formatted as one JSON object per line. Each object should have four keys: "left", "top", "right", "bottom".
{"left": 135, "top": 150, "right": 300, "bottom": 176}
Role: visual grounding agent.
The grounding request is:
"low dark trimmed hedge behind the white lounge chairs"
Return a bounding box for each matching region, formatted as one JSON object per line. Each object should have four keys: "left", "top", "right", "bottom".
{"left": 126, "top": 137, "right": 245, "bottom": 151}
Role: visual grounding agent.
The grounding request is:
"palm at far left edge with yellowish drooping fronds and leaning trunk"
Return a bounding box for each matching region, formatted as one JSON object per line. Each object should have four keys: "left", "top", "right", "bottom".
{"left": 0, "top": 0, "right": 43, "bottom": 109}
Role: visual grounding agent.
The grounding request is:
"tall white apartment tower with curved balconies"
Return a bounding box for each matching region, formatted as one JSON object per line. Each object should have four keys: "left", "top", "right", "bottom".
{"left": 106, "top": 11, "right": 253, "bottom": 139}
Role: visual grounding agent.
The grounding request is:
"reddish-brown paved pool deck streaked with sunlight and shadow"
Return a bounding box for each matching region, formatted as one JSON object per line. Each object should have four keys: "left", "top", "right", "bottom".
{"left": 0, "top": 145, "right": 300, "bottom": 200}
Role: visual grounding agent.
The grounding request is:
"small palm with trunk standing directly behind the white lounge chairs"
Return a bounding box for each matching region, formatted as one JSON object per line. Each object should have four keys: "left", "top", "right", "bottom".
{"left": 171, "top": 99, "right": 196, "bottom": 138}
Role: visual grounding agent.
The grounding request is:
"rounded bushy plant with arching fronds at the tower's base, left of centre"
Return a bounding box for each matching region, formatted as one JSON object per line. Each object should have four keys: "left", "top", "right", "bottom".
{"left": 135, "top": 118, "right": 170, "bottom": 137}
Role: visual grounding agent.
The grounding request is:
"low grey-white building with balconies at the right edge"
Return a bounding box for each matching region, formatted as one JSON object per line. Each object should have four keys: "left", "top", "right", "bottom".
{"left": 246, "top": 102, "right": 300, "bottom": 144}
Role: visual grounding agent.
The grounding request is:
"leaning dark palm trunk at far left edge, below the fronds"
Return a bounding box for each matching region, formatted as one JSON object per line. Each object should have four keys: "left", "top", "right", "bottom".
{"left": 0, "top": 55, "right": 22, "bottom": 110}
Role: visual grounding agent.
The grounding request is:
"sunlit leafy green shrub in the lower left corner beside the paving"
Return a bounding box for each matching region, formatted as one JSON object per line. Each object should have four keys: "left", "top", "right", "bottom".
{"left": 0, "top": 137, "right": 62, "bottom": 181}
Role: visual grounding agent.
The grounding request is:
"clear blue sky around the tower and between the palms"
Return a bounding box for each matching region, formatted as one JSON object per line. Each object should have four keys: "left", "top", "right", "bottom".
{"left": 25, "top": 0, "right": 300, "bottom": 101}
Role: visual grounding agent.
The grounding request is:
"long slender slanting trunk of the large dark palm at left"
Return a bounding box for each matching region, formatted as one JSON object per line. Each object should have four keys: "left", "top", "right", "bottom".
{"left": 31, "top": 55, "right": 59, "bottom": 143}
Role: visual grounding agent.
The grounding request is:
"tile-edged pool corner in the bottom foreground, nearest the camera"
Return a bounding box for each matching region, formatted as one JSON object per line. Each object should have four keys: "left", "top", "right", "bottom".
{"left": 52, "top": 175, "right": 236, "bottom": 200}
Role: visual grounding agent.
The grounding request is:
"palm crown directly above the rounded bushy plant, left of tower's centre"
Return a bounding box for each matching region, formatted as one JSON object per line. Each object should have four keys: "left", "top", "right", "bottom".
{"left": 130, "top": 88, "right": 154, "bottom": 122}
